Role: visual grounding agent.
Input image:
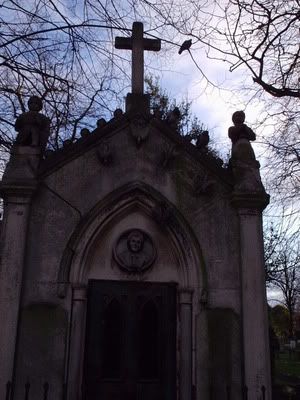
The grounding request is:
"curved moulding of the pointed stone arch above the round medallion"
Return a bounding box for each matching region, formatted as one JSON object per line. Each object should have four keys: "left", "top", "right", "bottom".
{"left": 58, "top": 182, "right": 207, "bottom": 290}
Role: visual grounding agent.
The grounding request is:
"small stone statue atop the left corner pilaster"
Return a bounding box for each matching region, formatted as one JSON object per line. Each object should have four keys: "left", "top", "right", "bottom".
{"left": 15, "top": 96, "right": 50, "bottom": 152}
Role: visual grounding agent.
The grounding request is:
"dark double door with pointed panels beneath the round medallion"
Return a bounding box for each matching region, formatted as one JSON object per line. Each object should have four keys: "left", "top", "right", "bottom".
{"left": 84, "top": 280, "right": 176, "bottom": 400}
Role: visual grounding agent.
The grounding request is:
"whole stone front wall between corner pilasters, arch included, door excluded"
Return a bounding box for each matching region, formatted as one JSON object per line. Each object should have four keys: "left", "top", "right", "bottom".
{"left": 0, "top": 117, "right": 246, "bottom": 400}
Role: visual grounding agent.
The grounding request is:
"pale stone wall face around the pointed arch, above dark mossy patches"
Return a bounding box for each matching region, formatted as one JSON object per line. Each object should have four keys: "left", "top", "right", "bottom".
{"left": 19, "top": 122, "right": 239, "bottom": 304}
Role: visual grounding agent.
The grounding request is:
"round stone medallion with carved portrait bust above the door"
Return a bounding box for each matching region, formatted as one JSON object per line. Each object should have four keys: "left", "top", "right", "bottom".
{"left": 113, "top": 229, "right": 156, "bottom": 273}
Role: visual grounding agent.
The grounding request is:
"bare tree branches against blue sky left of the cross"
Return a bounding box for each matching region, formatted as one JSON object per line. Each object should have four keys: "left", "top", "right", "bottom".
{"left": 0, "top": 0, "right": 144, "bottom": 152}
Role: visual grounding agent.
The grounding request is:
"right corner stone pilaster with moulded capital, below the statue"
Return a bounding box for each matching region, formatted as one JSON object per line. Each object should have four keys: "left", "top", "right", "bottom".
{"left": 232, "top": 192, "right": 271, "bottom": 400}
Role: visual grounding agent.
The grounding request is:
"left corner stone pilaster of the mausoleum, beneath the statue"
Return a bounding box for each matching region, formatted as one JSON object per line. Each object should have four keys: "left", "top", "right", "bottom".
{"left": 0, "top": 146, "right": 40, "bottom": 396}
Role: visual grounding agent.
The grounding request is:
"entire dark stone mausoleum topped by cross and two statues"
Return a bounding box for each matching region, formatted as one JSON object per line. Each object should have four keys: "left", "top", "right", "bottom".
{"left": 0, "top": 23, "right": 271, "bottom": 400}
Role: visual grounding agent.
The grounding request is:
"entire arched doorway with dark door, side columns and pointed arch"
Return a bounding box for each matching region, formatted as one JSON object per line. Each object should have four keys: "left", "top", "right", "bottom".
{"left": 60, "top": 184, "right": 206, "bottom": 400}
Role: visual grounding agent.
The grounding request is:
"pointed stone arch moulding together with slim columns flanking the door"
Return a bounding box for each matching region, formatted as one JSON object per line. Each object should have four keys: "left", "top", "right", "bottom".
{"left": 62, "top": 182, "right": 207, "bottom": 400}
